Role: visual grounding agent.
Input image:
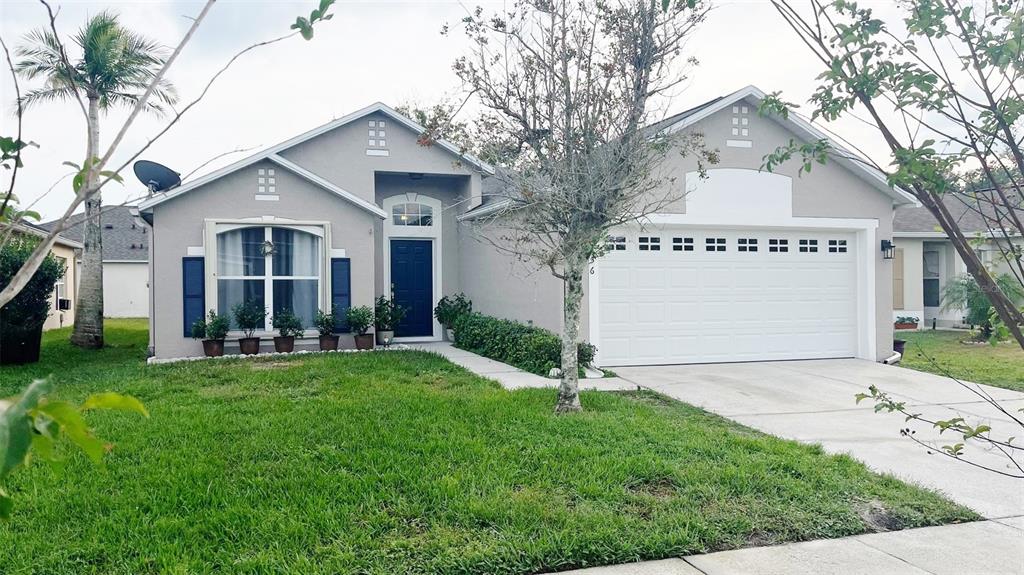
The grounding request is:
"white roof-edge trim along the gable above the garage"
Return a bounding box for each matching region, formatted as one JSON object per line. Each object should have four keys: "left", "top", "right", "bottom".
{"left": 655, "top": 86, "right": 918, "bottom": 206}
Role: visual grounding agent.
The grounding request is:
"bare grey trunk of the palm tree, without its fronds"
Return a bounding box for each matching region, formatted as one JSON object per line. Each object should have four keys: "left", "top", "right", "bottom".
{"left": 71, "top": 95, "right": 103, "bottom": 349}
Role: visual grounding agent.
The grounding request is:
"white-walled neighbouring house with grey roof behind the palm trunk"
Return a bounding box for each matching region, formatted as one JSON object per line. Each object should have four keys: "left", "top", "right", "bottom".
{"left": 43, "top": 206, "right": 150, "bottom": 317}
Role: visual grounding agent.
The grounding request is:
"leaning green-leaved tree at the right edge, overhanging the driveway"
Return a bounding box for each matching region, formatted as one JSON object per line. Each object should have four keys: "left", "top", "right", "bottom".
{"left": 762, "top": 0, "right": 1024, "bottom": 348}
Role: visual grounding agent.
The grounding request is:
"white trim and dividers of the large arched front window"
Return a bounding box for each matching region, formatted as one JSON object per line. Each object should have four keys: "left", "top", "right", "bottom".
{"left": 203, "top": 216, "right": 332, "bottom": 338}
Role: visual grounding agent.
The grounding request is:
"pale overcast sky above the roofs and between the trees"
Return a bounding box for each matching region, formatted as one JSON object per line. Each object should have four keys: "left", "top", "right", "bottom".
{"left": 0, "top": 0, "right": 893, "bottom": 220}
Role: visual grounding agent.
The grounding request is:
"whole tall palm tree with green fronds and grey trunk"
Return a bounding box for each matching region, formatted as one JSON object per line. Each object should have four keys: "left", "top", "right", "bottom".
{"left": 15, "top": 11, "right": 177, "bottom": 348}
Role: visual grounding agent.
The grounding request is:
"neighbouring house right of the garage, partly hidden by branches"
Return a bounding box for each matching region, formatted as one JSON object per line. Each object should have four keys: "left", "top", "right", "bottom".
{"left": 893, "top": 193, "right": 1024, "bottom": 327}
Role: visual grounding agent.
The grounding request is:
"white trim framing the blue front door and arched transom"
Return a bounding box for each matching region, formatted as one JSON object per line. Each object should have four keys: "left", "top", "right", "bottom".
{"left": 381, "top": 192, "right": 444, "bottom": 343}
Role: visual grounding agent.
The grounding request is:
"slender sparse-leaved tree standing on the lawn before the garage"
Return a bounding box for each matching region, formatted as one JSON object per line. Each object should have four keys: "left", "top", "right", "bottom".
{"left": 455, "top": 0, "right": 711, "bottom": 412}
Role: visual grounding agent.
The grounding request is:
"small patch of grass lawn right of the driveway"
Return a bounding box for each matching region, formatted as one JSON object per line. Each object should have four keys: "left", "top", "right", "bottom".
{"left": 896, "top": 330, "right": 1024, "bottom": 391}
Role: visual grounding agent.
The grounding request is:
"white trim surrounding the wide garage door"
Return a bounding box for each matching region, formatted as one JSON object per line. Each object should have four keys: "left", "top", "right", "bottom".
{"left": 587, "top": 214, "right": 880, "bottom": 365}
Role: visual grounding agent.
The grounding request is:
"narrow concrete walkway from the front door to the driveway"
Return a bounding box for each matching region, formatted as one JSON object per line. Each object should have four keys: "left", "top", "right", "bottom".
{"left": 406, "top": 342, "right": 638, "bottom": 391}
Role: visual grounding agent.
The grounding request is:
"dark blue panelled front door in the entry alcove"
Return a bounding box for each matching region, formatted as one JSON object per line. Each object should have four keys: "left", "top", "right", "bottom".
{"left": 391, "top": 239, "right": 434, "bottom": 338}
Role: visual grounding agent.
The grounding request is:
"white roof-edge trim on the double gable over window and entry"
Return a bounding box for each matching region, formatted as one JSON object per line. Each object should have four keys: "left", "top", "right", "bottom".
{"left": 138, "top": 102, "right": 495, "bottom": 212}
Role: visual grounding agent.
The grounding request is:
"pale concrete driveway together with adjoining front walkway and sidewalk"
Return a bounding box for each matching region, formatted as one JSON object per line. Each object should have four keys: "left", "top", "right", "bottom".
{"left": 411, "top": 343, "right": 1024, "bottom": 575}
